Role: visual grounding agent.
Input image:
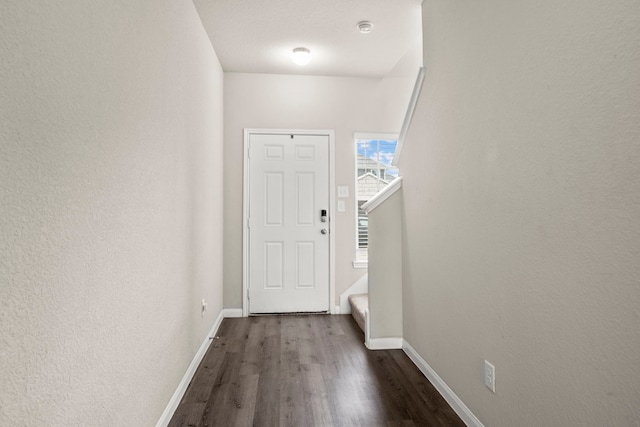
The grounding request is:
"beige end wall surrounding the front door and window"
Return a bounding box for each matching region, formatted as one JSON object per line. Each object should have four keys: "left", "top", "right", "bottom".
{"left": 224, "top": 72, "right": 419, "bottom": 308}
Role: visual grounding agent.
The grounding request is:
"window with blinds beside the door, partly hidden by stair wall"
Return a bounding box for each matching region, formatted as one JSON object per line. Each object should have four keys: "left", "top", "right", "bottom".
{"left": 354, "top": 135, "right": 398, "bottom": 265}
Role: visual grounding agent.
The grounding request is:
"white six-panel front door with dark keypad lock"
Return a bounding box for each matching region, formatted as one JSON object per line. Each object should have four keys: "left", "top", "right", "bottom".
{"left": 248, "top": 133, "right": 330, "bottom": 314}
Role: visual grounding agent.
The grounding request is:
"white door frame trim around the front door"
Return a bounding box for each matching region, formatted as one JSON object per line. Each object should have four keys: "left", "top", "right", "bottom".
{"left": 242, "top": 128, "right": 336, "bottom": 317}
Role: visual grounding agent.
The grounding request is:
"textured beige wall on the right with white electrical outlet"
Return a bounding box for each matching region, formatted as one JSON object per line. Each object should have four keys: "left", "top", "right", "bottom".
{"left": 400, "top": 0, "right": 640, "bottom": 427}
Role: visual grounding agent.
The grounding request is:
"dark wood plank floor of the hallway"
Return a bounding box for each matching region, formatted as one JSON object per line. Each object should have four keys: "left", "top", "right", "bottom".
{"left": 169, "top": 315, "right": 464, "bottom": 427}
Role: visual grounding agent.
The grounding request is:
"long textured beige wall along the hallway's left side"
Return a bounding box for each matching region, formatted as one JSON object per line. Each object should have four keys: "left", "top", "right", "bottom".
{"left": 0, "top": 0, "right": 222, "bottom": 426}
